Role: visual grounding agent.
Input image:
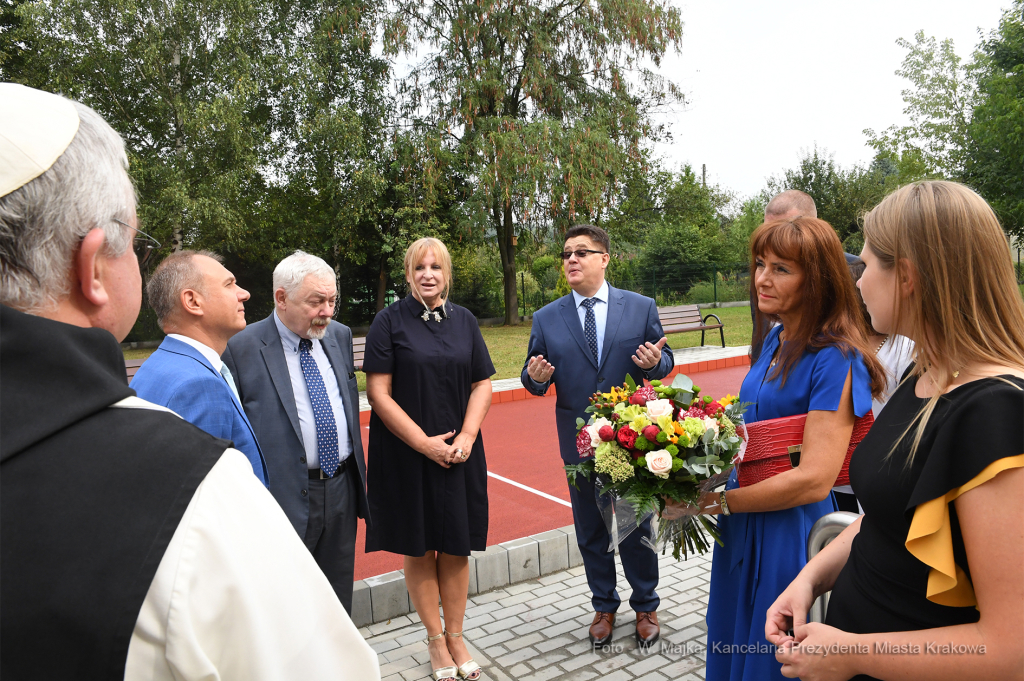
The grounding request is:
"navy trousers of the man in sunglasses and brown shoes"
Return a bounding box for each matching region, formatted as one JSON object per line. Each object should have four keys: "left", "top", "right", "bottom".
{"left": 569, "top": 475, "right": 660, "bottom": 612}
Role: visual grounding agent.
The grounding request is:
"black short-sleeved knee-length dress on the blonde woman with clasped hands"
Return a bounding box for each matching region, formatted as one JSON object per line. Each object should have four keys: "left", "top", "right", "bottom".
{"left": 362, "top": 296, "right": 495, "bottom": 557}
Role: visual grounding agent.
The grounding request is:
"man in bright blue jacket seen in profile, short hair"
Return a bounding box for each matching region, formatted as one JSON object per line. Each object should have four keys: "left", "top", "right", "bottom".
{"left": 131, "top": 251, "right": 268, "bottom": 484}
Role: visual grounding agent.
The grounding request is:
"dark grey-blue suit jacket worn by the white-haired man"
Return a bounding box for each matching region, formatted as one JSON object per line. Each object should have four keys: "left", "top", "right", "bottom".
{"left": 221, "top": 312, "right": 369, "bottom": 537}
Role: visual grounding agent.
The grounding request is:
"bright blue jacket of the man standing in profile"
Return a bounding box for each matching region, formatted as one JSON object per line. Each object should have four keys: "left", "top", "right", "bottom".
{"left": 131, "top": 337, "right": 267, "bottom": 484}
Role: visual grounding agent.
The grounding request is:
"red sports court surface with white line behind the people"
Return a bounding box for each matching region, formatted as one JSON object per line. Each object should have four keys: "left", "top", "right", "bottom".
{"left": 355, "top": 367, "right": 749, "bottom": 580}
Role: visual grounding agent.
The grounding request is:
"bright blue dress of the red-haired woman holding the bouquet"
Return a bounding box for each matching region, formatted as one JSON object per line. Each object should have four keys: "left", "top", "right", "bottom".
{"left": 706, "top": 326, "right": 871, "bottom": 681}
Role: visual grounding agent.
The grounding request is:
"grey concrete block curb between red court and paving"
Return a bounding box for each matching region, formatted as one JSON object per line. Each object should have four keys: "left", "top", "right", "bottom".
{"left": 352, "top": 525, "right": 583, "bottom": 627}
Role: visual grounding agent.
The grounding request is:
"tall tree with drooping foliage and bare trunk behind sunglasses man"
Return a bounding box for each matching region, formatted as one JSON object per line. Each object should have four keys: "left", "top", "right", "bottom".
{"left": 385, "top": 0, "right": 682, "bottom": 324}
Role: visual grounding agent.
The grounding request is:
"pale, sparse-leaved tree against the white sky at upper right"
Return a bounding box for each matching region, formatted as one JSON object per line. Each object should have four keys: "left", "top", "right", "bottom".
{"left": 864, "top": 31, "right": 978, "bottom": 179}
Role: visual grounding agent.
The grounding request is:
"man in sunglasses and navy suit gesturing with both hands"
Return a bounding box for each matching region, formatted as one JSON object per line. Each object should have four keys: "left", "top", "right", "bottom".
{"left": 522, "top": 224, "right": 675, "bottom": 646}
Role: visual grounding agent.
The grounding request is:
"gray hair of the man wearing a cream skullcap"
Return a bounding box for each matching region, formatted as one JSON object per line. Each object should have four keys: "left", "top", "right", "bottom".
{"left": 0, "top": 101, "right": 135, "bottom": 312}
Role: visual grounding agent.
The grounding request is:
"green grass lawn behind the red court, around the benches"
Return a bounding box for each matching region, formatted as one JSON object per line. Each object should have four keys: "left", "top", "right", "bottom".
{"left": 124, "top": 306, "right": 753, "bottom": 390}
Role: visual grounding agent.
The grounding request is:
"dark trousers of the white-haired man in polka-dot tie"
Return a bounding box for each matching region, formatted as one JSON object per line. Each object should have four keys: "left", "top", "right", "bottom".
{"left": 303, "top": 457, "right": 358, "bottom": 614}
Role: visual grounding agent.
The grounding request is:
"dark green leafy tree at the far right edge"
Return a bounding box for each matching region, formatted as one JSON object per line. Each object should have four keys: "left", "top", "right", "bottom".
{"left": 965, "top": 0, "right": 1024, "bottom": 238}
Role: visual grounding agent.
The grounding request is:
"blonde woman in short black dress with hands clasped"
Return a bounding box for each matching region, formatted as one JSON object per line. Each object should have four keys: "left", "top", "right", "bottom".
{"left": 362, "top": 239, "right": 495, "bottom": 681}
